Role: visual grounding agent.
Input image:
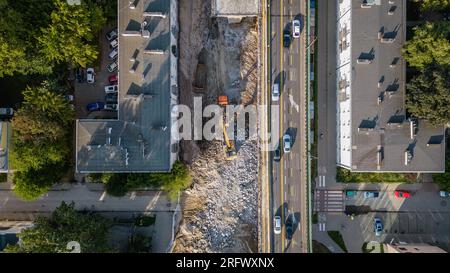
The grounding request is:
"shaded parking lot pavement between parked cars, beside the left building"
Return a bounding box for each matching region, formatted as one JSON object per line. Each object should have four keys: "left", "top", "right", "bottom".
{"left": 75, "top": 27, "right": 117, "bottom": 119}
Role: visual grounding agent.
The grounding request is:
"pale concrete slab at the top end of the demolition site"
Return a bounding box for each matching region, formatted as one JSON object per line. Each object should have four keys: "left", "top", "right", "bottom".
{"left": 211, "top": 0, "right": 259, "bottom": 17}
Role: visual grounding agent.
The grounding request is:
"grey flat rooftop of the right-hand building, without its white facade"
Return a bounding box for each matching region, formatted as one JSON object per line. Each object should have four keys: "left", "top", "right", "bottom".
{"left": 351, "top": 0, "right": 445, "bottom": 172}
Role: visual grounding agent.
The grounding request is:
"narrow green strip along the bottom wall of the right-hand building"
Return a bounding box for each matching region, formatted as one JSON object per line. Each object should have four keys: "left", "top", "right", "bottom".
{"left": 336, "top": 167, "right": 417, "bottom": 183}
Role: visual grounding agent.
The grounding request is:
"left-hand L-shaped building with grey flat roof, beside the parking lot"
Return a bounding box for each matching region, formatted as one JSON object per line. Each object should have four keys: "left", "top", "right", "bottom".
{"left": 76, "top": 0, "right": 178, "bottom": 173}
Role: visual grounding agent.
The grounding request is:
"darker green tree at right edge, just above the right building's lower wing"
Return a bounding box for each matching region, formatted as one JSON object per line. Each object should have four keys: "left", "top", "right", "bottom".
{"left": 406, "top": 67, "right": 450, "bottom": 126}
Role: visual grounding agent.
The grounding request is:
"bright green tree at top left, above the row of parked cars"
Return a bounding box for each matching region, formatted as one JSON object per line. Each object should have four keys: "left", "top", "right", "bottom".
{"left": 38, "top": 0, "right": 106, "bottom": 67}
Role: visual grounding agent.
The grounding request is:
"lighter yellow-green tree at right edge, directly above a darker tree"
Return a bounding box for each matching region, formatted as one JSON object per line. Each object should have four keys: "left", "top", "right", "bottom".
{"left": 402, "top": 22, "right": 450, "bottom": 69}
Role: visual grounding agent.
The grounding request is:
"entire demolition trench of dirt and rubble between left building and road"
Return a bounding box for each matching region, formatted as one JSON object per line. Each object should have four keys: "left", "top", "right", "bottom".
{"left": 173, "top": 0, "right": 260, "bottom": 253}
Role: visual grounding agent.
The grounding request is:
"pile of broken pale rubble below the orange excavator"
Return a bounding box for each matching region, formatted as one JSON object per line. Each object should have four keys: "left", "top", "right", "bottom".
{"left": 174, "top": 140, "right": 259, "bottom": 252}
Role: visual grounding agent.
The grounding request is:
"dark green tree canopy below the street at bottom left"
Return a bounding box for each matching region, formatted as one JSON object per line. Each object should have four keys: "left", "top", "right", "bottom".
{"left": 5, "top": 202, "right": 111, "bottom": 253}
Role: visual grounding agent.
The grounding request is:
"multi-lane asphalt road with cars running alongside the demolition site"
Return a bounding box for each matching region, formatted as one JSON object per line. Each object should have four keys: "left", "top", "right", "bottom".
{"left": 268, "top": 0, "right": 308, "bottom": 253}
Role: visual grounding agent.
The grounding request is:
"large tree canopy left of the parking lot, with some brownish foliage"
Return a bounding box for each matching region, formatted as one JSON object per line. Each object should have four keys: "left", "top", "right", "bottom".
{"left": 10, "top": 82, "right": 74, "bottom": 200}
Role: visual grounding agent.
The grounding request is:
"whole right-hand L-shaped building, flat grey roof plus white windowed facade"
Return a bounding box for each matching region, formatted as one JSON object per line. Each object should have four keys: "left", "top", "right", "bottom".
{"left": 336, "top": 0, "right": 445, "bottom": 172}
